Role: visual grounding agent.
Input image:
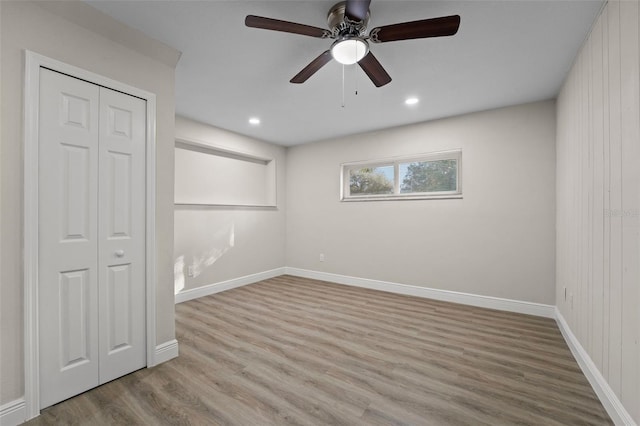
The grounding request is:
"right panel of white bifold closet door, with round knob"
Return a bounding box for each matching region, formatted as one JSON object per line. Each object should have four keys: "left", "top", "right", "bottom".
{"left": 98, "top": 88, "right": 147, "bottom": 383}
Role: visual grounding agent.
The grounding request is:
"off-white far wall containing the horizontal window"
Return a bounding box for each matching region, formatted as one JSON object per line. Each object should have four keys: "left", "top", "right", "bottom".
{"left": 286, "top": 101, "right": 555, "bottom": 304}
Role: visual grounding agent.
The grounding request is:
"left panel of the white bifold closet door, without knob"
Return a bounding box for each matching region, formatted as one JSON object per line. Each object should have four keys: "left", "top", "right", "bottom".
{"left": 38, "top": 69, "right": 99, "bottom": 407}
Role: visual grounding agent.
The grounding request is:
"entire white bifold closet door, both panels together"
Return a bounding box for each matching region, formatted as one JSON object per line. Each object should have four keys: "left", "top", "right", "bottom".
{"left": 38, "top": 69, "right": 146, "bottom": 408}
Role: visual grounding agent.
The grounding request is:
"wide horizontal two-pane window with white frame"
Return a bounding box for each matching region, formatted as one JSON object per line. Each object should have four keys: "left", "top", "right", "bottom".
{"left": 341, "top": 150, "right": 462, "bottom": 201}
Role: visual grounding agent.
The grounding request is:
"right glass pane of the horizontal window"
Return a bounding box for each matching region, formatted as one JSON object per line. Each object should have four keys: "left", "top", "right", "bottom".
{"left": 399, "top": 160, "right": 458, "bottom": 194}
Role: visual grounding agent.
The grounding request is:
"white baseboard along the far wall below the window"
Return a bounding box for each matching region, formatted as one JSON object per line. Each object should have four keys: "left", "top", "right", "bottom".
{"left": 285, "top": 267, "right": 555, "bottom": 318}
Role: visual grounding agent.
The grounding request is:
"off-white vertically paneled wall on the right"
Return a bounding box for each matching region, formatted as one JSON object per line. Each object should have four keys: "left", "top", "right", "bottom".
{"left": 556, "top": 0, "right": 640, "bottom": 423}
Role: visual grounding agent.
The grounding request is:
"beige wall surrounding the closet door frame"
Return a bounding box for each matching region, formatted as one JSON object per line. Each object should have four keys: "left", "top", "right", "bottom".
{"left": 0, "top": 1, "right": 179, "bottom": 405}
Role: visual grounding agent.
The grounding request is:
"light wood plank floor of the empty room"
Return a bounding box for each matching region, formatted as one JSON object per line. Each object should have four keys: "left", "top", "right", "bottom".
{"left": 28, "top": 276, "right": 611, "bottom": 425}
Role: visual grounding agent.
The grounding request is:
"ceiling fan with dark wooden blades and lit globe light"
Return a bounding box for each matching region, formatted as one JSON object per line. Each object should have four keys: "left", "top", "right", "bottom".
{"left": 244, "top": 0, "right": 460, "bottom": 87}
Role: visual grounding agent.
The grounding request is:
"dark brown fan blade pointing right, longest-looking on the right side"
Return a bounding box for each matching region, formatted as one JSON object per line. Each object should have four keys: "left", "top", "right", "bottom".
{"left": 369, "top": 15, "right": 460, "bottom": 43}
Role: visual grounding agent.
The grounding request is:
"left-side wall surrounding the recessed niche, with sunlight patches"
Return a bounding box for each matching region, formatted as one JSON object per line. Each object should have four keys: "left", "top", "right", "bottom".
{"left": 174, "top": 117, "right": 286, "bottom": 291}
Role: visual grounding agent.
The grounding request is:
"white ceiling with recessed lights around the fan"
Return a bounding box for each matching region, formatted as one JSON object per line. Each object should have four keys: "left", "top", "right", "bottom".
{"left": 88, "top": 0, "right": 603, "bottom": 146}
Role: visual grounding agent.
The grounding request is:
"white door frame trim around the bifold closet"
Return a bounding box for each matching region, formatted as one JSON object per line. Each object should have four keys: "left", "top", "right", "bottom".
{"left": 23, "top": 50, "right": 156, "bottom": 419}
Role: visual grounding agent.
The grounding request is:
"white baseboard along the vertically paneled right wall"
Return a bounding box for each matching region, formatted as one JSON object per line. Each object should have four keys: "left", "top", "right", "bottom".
{"left": 555, "top": 308, "right": 637, "bottom": 426}
